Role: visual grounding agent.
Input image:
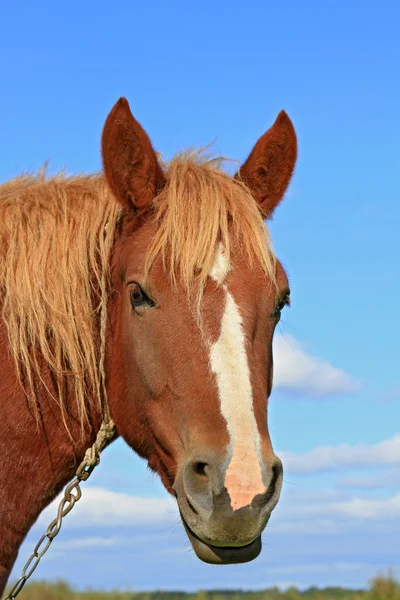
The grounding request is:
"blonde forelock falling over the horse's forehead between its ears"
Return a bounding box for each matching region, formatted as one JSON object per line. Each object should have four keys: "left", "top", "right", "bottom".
{"left": 145, "top": 150, "right": 276, "bottom": 308}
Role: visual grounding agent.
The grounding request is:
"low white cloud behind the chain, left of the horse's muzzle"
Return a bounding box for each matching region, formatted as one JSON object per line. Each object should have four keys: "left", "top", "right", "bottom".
{"left": 37, "top": 485, "right": 177, "bottom": 527}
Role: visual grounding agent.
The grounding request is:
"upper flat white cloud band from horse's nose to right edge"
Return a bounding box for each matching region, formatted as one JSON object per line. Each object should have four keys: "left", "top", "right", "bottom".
{"left": 280, "top": 434, "right": 400, "bottom": 473}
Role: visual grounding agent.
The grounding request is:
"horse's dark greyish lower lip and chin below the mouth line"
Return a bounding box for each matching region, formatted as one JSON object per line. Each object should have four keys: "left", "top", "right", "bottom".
{"left": 181, "top": 515, "right": 262, "bottom": 565}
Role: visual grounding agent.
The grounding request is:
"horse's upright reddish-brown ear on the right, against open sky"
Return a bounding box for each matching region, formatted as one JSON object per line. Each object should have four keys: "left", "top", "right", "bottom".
{"left": 235, "top": 110, "right": 297, "bottom": 218}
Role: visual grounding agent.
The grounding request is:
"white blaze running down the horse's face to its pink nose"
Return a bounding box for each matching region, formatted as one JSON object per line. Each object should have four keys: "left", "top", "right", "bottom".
{"left": 210, "top": 248, "right": 266, "bottom": 510}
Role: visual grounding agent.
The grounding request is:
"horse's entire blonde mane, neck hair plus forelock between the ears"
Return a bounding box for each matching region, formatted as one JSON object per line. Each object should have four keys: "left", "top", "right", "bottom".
{"left": 0, "top": 153, "right": 275, "bottom": 427}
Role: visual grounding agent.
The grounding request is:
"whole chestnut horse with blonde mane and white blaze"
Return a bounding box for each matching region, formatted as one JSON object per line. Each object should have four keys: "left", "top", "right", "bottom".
{"left": 0, "top": 98, "right": 297, "bottom": 592}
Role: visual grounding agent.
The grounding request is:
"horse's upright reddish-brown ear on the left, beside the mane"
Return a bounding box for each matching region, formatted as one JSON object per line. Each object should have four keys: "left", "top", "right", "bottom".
{"left": 101, "top": 98, "right": 165, "bottom": 211}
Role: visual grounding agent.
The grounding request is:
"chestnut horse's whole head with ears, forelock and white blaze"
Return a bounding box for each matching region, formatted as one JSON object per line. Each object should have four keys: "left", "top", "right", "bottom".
{"left": 102, "top": 98, "right": 297, "bottom": 563}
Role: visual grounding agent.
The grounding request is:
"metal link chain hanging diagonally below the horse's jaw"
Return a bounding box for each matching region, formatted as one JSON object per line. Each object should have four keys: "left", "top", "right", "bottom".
{"left": 3, "top": 420, "right": 115, "bottom": 600}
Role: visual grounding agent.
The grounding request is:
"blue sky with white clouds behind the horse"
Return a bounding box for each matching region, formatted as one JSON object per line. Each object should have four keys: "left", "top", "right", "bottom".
{"left": 0, "top": 0, "right": 400, "bottom": 589}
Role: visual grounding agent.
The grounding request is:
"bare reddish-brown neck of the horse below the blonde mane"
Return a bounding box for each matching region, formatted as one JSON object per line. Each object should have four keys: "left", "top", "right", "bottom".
{"left": 0, "top": 320, "right": 101, "bottom": 596}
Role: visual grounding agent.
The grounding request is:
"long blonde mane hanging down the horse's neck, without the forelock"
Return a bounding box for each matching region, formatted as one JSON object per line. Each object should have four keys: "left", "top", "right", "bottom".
{"left": 0, "top": 169, "right": 119, "bottom": 426}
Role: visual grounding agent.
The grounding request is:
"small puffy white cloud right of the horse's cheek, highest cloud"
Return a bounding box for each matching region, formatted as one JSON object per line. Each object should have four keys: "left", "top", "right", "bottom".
{"left": 274, "top": 335, "right": 359, "bottom": 396}
